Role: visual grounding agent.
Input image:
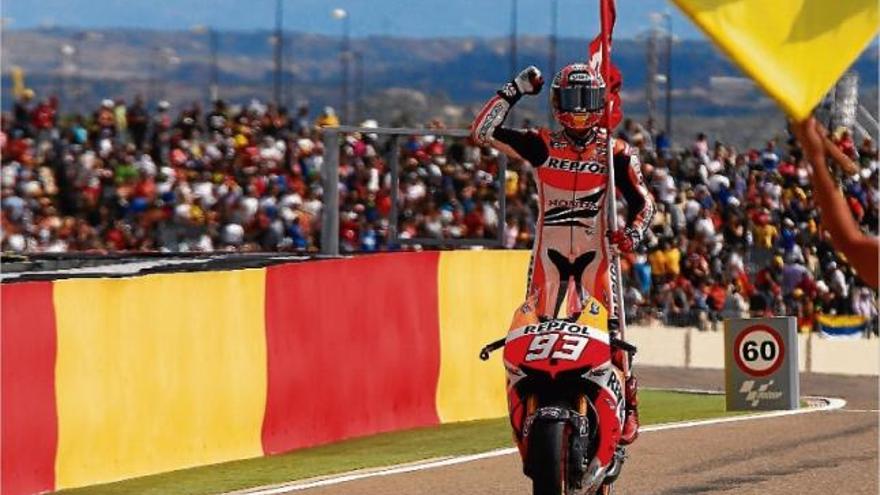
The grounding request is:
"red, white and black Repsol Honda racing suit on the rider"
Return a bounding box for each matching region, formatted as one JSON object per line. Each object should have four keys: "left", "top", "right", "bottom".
{"left": 471, "top": 91, "right": 654, "bottom": 317}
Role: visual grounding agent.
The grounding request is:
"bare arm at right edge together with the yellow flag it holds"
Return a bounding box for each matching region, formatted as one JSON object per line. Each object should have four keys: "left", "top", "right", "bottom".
{"left": 672, "top": 0, "right": 880, "bottom": 289}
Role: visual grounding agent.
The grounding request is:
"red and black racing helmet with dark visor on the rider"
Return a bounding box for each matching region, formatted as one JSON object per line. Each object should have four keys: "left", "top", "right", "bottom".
{"left": 550, "top": 63, "right": 605, "bottom": 131}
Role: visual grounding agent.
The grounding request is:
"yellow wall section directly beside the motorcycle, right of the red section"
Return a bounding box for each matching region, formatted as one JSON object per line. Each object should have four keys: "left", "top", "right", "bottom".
{"left": 437, "top": 251, "right": 529, "bottom": 423}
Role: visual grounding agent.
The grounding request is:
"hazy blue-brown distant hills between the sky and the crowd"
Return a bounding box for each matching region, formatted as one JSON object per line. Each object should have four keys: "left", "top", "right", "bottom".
{"left": 2, "top": 28, "right": 878, "bottom": 145}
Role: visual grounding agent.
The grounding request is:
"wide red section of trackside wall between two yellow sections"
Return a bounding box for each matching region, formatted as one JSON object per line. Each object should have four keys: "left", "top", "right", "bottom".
{"left": 262, "top": 253, "right": 440, "bottom": 454}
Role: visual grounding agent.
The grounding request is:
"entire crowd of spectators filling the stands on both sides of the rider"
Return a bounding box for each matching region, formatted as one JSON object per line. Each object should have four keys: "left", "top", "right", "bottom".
{"left": 0, "top": 90, "right": 880, "bottom": 334}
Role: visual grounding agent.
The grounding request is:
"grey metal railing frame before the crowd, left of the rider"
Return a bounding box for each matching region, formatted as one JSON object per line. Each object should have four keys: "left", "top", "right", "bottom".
{"left": 321, "top": 126, "right": 507, "bottom": 256}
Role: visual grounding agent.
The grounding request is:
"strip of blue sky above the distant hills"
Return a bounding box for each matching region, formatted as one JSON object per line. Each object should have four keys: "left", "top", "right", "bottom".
{"left": 2, "top": 0, "right": 702, "bottom": 38}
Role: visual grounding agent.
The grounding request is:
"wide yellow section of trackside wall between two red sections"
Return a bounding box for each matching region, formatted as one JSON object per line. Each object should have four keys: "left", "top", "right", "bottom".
{"left": 54, "top": 269, "right": 266, "bottom": 489}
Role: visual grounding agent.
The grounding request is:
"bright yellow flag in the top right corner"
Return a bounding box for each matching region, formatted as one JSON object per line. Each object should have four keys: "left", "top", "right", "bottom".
{"left": 673, "top": 0, "right": 878, "bottom": 121}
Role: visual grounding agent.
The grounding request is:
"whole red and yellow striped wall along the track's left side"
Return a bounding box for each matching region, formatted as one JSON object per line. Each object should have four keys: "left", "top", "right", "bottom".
{"left": 0, "top": 251, "right": 528, "bottom": 495}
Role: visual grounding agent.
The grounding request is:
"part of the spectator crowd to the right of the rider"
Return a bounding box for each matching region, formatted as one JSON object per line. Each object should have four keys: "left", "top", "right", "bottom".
{"left": 623, "top": 118, "right": 880, "bottom": 334}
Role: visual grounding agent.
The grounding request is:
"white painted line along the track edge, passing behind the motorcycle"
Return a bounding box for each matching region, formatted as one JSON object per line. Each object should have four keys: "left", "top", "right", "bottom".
{"left": 235, "top": 398, "right": 846, "bottom": 495}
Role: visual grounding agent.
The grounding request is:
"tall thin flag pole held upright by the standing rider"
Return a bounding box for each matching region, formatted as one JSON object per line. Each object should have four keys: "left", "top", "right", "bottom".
{"left": 599, "top": 0, "right": 629, "bottom": 377}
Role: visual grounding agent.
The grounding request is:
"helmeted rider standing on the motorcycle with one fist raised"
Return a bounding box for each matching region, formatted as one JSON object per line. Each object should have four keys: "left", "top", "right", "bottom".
{"left": 471, "top": 63, "right": 654, "bottom": 445}
